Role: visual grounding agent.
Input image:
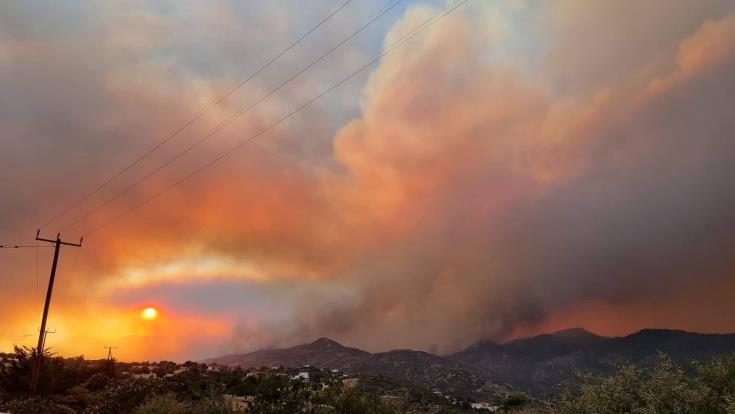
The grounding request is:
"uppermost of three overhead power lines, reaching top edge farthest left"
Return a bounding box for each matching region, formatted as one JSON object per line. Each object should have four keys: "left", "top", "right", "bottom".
{"left": 40, "top": 0, "right": 352, "bottom": 228}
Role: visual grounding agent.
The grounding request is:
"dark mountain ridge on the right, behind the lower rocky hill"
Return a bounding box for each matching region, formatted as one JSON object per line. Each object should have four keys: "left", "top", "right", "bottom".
{"left": 449, "top": 328, "right": 735, "bottom": 396}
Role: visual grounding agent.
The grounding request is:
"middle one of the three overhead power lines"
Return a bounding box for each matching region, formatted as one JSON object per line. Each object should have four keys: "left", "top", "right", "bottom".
{"left": 61, "top": 0, "right": 403, "bottom": 232}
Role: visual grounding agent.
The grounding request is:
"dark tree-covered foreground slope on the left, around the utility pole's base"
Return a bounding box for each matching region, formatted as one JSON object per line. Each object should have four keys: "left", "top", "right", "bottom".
{"left": 0, "top": 349, "right": 461, "bottom": 414}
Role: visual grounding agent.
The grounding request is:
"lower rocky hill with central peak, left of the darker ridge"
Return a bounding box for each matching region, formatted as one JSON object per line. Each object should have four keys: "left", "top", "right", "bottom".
{"left": 205, "top": 338, "right": 508, "bottom": 398}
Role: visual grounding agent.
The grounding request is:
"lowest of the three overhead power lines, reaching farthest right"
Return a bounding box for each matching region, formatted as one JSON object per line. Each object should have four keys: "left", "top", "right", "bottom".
{"left": 85, "top": 0, "right": 469, "bottom": 237}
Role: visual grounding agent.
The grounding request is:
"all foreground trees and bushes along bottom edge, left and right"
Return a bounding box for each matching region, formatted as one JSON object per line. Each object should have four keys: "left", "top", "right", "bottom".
{"left": 14, "top": 349, "right": 735, "bottom": 414}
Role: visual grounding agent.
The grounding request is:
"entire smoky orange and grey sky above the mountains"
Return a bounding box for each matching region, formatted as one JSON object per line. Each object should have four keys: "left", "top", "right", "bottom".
{"left": 0, "top": 0, "right": 735, "bottom": 360}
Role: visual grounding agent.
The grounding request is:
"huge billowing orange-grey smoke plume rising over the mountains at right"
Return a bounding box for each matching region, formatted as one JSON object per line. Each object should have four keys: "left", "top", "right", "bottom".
{"left": 243, "top": 8, "right": 735, "bottom": 351}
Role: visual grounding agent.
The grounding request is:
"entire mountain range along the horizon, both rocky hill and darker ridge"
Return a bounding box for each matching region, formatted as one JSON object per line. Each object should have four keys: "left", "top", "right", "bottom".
{"left": 206, "top": 328, "right": 735, "bottom": 399}
